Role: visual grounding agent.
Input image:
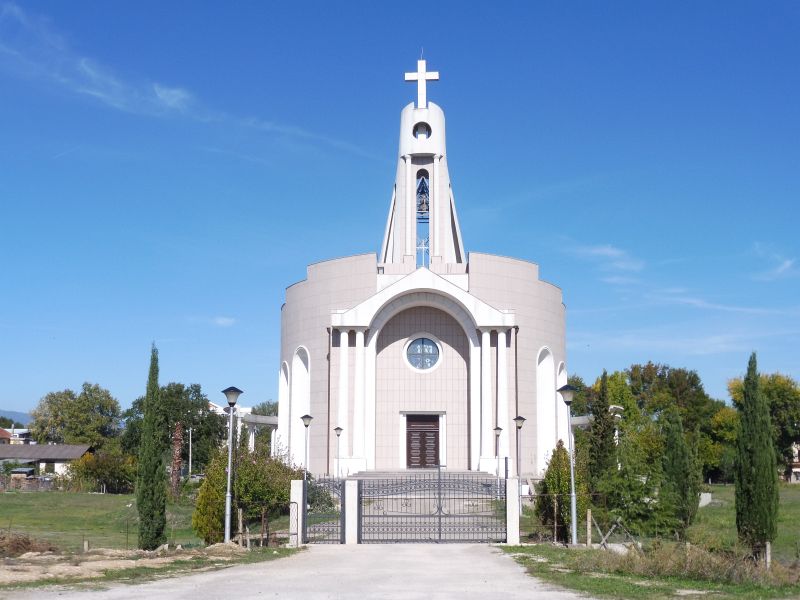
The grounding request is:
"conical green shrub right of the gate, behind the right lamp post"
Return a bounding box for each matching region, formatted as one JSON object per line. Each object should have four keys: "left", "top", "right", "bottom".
{"left": 534, "top": 440, "right": 589, "bottom": 542}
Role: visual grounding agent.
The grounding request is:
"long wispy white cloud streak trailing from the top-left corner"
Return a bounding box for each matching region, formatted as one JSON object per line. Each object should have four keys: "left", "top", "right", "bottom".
{"left": 0, "top": 3, "right": 376, "bottom": 159}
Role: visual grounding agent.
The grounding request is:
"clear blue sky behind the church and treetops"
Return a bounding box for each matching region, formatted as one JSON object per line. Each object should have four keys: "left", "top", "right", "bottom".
{"left": 0, "top": 0, "right": 800, "bottom": 410}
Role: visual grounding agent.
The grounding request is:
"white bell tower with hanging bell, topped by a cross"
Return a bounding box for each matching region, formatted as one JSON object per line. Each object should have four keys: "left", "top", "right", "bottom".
{"left": 379, "top": 60, "right": 466, "bottom": 274}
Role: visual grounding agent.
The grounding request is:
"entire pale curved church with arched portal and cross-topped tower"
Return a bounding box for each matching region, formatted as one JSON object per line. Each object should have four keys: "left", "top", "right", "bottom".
{"left": 273, "top": 60, "right": 568, "bottom": 478}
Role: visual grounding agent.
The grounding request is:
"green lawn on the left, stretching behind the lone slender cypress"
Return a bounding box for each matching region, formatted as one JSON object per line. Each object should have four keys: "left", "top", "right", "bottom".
{"left": 0, "top": 492, "right": 201, "bottom": 551}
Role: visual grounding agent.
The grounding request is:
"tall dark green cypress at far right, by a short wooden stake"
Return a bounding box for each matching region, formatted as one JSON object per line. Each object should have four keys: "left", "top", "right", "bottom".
{"left": 735, "top": 352, "right": 778, "bottom": 556}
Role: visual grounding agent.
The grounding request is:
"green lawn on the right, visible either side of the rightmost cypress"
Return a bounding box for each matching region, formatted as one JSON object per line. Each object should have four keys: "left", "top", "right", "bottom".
{"left": 688, "top": 484, "right": 800, "bottom": 564}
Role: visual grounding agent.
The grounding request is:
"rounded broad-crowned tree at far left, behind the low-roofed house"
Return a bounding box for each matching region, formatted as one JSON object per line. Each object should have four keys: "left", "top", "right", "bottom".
{"left": 30, "top": 382, "right": 121, "bottom": 448}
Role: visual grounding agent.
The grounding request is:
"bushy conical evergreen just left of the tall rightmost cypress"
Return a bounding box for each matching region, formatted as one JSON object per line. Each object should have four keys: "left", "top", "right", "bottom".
{"left": 661, "top": 408, "right": 700, "bottom": 538}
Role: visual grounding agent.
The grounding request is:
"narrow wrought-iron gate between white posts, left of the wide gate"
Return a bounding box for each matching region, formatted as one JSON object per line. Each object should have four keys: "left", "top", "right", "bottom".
{"left": 303, "top": 479, "right": 345, "bottom": 544}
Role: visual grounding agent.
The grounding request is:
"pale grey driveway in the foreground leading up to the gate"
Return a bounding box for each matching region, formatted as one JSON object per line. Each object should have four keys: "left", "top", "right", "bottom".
{"left": 6, "top": 544, "right": 585, "bottom": 600}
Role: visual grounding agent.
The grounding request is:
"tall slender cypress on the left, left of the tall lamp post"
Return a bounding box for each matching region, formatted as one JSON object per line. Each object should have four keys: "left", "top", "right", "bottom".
{"left": 136, "top": 344, "right": 167, "bottom": 550}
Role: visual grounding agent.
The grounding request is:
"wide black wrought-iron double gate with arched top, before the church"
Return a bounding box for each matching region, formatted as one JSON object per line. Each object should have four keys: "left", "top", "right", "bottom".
{"left": 358, "top": 468, "right": 506, "bottom": 544}
